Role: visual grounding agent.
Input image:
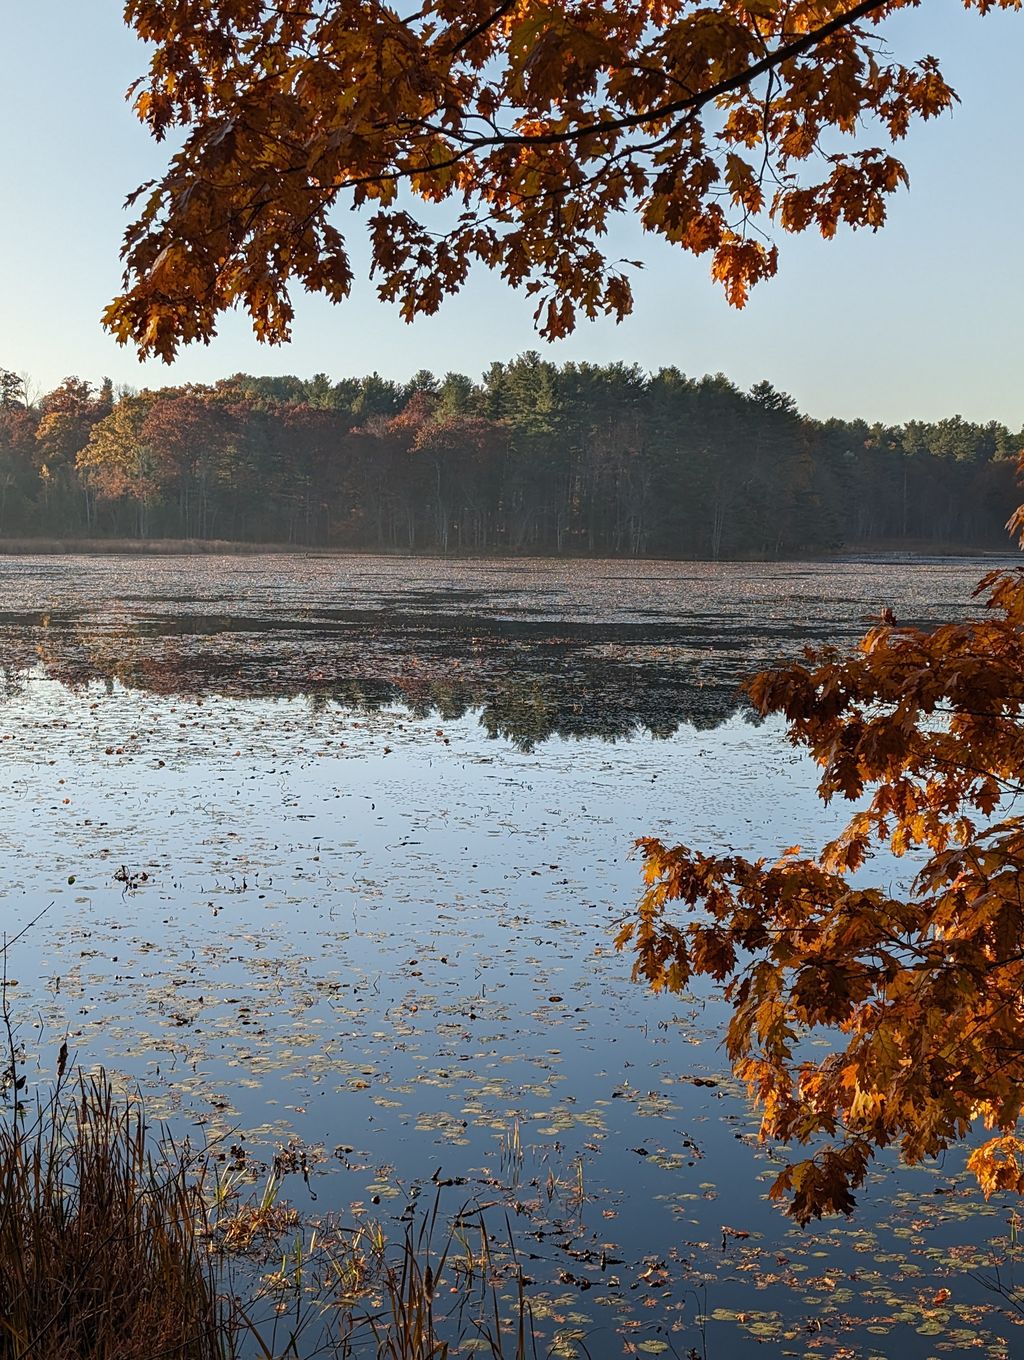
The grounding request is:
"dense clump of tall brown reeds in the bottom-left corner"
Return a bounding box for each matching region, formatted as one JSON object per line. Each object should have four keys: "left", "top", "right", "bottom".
{"left": 0, "top": 1076, "right": 238, "bottom": 1360}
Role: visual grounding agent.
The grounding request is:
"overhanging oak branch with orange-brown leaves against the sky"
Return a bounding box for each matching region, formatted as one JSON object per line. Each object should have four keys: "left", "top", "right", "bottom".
{"left": 105, "top": 0, "right": 1021, "bottom": 360}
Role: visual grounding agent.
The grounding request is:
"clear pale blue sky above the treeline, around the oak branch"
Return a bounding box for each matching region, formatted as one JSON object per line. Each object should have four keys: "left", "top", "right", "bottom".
{"left": 0, "top": 0, "right": 1024, "bottom": 431}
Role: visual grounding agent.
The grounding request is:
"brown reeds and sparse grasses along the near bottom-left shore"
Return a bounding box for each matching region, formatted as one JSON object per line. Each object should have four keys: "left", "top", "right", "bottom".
{"left": 0, "top": 1057, "right": 536, "bottom": 1360}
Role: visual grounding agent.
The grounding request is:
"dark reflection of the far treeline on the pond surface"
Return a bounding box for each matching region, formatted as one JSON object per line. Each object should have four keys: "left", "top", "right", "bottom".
{"left": 0, "top": 611, "right": 772, "bottom": 751}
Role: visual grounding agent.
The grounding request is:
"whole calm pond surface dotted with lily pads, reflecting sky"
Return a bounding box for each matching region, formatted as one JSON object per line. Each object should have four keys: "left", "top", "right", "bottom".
{"left": 0, "top": 556, "right": 1021, "bottom": 1360}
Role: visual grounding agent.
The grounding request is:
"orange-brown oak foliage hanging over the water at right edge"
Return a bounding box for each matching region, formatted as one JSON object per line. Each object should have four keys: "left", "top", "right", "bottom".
{"left": 619, "top": 489, "right": 1024, "bottom": 1221}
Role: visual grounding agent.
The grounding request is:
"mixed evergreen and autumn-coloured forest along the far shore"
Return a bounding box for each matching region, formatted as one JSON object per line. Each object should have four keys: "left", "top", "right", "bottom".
{"left": 0, "top": 354, "right": 1024, "bottom": 560}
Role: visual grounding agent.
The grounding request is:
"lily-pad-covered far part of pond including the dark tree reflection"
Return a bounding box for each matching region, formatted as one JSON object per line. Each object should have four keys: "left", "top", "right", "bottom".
{"left": 0, "top": 556, "right": 991, "bottom": 751}
